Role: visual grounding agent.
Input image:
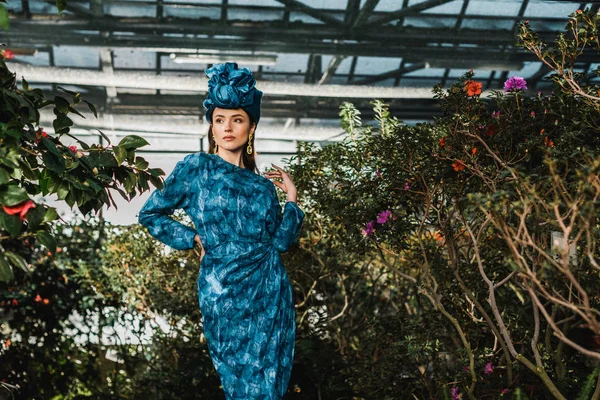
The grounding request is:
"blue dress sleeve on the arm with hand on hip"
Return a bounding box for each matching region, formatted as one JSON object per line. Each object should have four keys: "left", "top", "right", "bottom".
{"left": 138, "top": 156, "right": 197, "bottom": 250}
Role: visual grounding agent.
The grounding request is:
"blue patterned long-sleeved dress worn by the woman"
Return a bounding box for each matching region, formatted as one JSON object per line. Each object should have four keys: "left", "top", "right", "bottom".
{"left": 138, "top": 152, "right": 304, "bottom": 400}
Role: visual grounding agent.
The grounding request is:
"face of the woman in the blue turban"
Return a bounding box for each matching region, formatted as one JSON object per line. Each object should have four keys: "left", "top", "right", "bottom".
{"left": 212, "top": 107, "right": 256, "bottom": 151}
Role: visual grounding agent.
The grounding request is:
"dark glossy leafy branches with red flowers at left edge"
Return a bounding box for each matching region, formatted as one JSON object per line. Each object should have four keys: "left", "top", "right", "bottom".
{"left": 0, "top": 60, "right": 164, "bottom": 282}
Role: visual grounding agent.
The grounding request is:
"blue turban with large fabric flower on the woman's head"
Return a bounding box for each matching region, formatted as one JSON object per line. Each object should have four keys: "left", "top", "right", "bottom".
{"left": 204, "top": 62, "right": 262, "bottom": 124}
